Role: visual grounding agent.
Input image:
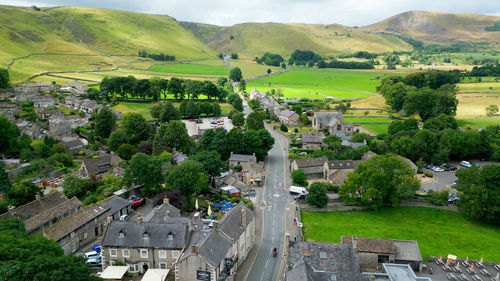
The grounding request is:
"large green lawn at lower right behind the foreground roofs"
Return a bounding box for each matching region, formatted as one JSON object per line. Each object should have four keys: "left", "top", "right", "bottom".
{"left": 301, "top": 207, "right": 500, "bottom": 262}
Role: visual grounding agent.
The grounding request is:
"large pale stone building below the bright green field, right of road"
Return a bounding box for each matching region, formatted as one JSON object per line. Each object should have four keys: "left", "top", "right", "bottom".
{"left": 312, "top": 112, "right": 354, "bottom": 136}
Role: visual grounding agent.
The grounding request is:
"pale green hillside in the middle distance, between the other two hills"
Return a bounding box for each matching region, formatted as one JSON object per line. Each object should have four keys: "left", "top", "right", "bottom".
{"left": 201, "top": 23, "right": 411, "bottom": 59}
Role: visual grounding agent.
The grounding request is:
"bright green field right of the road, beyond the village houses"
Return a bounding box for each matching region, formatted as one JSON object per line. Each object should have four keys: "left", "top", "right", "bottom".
{"left": 247, "top": 68, "right": 387, "bottom": 99}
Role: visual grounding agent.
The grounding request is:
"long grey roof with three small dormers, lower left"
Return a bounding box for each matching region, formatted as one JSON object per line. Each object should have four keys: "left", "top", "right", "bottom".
{"left": 102, "top": 220, "right": 188, "bottom": 249}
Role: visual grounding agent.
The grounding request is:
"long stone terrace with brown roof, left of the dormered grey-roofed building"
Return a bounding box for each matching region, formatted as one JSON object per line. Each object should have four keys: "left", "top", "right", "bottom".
{"left": 42, "top": 204, "right": 111, "bottom": 255}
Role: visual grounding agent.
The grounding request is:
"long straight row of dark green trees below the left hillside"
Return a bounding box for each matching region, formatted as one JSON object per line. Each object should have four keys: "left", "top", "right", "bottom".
{"left": 99, "top": 76, "right": 232, "bottom": 101}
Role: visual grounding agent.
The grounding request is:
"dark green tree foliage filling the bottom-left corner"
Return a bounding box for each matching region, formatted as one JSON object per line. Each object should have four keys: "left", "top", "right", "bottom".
{"left": 0, "top": 218, "right": 102, "bottom": 281}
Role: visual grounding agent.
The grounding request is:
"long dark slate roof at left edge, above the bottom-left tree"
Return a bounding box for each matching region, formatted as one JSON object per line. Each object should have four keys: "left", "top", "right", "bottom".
{"left": 0, "top": 191, "right": 73, "bottom": 221}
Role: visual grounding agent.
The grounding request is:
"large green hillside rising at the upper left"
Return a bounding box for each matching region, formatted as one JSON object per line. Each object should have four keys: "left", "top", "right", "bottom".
{"left": 0, "top": 6, "right": 215, "bottom": 82}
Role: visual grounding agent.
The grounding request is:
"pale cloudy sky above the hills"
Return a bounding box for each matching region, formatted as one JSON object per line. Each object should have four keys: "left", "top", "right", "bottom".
{"left": 0, "top": 0, "right": 500, "bottom": 26}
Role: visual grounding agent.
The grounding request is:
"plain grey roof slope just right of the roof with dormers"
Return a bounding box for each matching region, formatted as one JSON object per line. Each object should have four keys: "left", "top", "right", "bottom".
{"left": 199, "top": 230, "right": 232, "bottom": 267}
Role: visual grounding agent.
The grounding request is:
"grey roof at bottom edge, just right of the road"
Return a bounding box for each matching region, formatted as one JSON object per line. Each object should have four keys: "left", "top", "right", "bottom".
{"left": 286, "top": 241, "right": 361, "bottom": 281}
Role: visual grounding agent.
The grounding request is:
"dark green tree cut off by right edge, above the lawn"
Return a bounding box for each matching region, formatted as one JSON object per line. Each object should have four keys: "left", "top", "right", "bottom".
{"left": 456, "top": 165, "right": 500, "bottom": 225}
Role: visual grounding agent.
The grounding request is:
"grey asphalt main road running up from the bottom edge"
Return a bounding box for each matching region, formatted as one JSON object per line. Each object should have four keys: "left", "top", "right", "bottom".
{"left": 246, "top": 124, "right": 293, "bottom": 281}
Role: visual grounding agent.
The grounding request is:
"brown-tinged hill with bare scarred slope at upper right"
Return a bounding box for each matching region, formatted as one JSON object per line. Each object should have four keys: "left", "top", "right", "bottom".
{"left": 361, "top": 11, "right": 500, "bottom": 48}
